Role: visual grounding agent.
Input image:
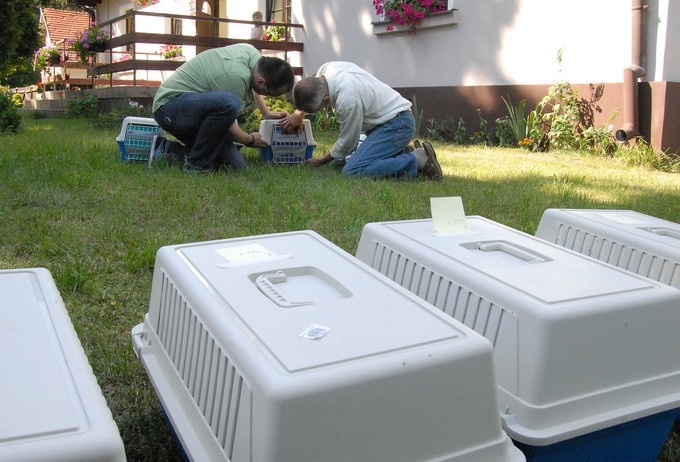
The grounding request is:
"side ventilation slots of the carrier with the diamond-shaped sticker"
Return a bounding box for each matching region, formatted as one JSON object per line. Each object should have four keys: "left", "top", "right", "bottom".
{"left": 155, "top": 274, "right": 248, "bottom": 460}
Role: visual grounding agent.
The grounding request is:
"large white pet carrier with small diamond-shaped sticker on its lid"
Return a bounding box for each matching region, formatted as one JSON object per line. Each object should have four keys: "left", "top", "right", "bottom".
{"left": 132, "top": 231, "right": 525, "bottom": 462}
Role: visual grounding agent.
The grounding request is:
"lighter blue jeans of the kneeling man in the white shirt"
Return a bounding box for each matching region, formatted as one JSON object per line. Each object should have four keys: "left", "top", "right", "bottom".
{"left": 342, "top": 111, "right": 418, "bottom": 178}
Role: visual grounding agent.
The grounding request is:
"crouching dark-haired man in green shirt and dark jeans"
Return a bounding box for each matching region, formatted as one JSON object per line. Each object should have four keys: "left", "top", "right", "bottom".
{"left": 152, "top": 43, "right": 294, "bottom": 172}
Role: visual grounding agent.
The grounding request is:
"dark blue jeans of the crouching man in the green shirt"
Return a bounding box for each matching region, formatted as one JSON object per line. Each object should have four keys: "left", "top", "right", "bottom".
{"left": 153, "top": 91, "right": 246, "bottom": 170}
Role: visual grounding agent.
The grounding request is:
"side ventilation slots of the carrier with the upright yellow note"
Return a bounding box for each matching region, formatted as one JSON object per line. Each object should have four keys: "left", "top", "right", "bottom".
{"left": 372, "top": 243, "right": 510, "bottom": 346}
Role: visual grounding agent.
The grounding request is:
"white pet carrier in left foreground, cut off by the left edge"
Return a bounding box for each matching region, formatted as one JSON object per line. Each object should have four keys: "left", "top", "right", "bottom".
{"left": 0, "top": 268, "right": 125, "bottom": 462}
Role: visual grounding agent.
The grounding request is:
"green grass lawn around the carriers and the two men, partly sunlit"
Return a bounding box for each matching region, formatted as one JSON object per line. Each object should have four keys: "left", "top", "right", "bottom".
{"left": 0, "top": 119, "right": 680, "bottom": 461}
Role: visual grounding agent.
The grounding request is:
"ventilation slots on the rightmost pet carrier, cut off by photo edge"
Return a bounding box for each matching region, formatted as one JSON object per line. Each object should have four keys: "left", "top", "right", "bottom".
{"left": 554, "top": 224, "right": 680, "bottom": 288}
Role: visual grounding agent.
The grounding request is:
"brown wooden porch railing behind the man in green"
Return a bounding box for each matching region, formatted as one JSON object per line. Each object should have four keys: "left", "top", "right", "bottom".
{"left": 87, "top": 11, "right": 304, "bottom": 86}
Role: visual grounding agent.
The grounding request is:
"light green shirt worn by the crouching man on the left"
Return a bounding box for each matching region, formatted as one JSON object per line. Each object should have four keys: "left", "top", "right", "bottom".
{"left": 152, "top": 43, "right": 262, "bottom": 112}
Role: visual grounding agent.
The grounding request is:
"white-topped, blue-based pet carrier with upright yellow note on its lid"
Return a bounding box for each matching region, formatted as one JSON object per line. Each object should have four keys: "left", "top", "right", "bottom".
{"left": 357, "top": 216, "right": 680, "bottom": 461}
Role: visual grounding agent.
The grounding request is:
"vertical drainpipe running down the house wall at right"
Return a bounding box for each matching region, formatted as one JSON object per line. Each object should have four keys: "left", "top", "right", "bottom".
{"left": 616, "top": 0, "right": 648, "bottom": 141}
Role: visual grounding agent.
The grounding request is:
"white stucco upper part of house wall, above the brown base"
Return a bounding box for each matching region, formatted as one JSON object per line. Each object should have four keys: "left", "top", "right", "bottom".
{"left": 294, "top": 0, "right": 680, "bottom": 87}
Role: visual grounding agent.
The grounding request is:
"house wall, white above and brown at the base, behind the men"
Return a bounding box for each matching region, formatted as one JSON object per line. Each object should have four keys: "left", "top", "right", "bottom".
{"left": 293, "top": 0, "right": 680, "bottom": 152}
